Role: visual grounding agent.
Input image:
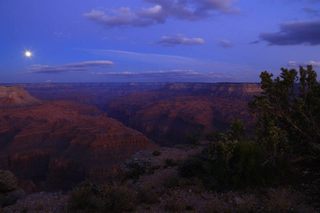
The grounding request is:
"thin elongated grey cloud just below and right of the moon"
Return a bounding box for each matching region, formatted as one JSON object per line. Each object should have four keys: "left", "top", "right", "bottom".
{"left": 29, "top": 60, "right": 113, "bottom": 73}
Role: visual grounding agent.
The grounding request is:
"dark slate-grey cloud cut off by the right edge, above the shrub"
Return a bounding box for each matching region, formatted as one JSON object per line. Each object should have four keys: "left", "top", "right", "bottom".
{"left": 260, "top": 20, "right": 320, "bottom": 45}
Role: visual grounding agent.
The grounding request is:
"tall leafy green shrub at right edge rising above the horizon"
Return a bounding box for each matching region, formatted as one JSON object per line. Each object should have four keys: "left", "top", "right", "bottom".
{"left": 250, "top": 66, "right": 320, "bottom": 158}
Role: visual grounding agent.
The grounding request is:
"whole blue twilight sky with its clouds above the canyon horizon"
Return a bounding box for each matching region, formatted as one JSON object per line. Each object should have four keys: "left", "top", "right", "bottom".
{"left": 0, "top": 0, "right": 320, "bottom": 83}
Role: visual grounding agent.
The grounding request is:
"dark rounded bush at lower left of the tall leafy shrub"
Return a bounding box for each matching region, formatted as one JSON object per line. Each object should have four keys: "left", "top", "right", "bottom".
{"left": 179, "top": 121, "right": 288, "bottom": 190}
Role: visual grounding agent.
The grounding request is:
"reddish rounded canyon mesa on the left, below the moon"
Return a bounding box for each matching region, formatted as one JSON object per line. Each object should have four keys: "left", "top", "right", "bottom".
{"left": 0, "top": 101, "right": 152, "bottom": 189}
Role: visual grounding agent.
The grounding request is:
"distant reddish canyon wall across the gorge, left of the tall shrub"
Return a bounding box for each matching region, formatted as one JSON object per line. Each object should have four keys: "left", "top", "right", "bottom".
{"left": 107, "top": 83, "right": 261, "bottom": 145}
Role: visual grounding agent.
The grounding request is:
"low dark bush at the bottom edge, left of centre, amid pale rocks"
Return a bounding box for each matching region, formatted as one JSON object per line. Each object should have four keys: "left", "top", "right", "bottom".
{"left": 68, "top": 183, "right": 136, "bottom": 212}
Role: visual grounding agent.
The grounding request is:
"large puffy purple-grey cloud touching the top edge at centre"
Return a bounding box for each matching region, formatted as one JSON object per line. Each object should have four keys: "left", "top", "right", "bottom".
{"left": 84, "top": 0, "right": 238, "bottom": 27}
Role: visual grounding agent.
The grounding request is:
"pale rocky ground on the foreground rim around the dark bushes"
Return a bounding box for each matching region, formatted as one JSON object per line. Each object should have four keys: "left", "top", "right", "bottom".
{"left": 2, "top": 143, "right": 317, "bottom": 213}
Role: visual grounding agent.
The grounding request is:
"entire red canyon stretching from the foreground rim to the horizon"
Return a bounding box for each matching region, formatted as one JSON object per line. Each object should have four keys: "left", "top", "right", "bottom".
{"left": 0, "top": 83, "right": 261, "bottom": 191}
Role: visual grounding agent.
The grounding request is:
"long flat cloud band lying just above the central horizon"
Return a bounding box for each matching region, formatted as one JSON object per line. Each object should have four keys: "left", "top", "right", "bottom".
{"left": 95, "top": 69, "right": 231, "bottom": 82}
